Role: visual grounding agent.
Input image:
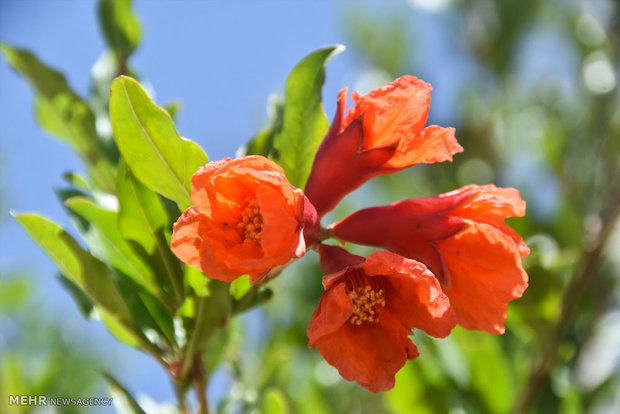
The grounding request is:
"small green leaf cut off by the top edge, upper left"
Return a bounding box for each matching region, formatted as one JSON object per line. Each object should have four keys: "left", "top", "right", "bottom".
{"left": 99, "top": 0, "right": 140, "bottom": 61}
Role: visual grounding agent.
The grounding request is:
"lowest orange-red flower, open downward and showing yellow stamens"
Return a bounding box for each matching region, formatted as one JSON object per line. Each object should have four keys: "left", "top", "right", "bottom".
{"left": 308, "top": 245, "right": 454, "bottom": 392}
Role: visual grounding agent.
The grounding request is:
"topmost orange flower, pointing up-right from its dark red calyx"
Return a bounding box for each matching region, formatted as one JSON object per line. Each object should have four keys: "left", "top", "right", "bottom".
{"left": 305, "top": 76, "right": 463, "bottom": 216}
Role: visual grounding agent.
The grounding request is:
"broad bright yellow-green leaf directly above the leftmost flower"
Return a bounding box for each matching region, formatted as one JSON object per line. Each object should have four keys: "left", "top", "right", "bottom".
{"left": 110, "top": 76, "right": 208, "bottom": 210}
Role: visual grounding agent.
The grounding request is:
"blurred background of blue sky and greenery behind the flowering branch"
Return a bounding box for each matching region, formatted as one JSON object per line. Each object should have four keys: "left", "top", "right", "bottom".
{"left": 0, "top": 0, "right": 620, "bottom": 413}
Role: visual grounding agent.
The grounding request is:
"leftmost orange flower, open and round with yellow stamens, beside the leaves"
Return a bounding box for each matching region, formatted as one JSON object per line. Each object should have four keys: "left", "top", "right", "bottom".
{"left": 171, "top": 156, "right": 318, "bottom": 282}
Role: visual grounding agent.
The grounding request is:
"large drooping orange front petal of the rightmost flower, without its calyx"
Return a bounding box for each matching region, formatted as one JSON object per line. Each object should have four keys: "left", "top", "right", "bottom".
{"left": 437, "top": 223, "right": 527, "bottom": 333}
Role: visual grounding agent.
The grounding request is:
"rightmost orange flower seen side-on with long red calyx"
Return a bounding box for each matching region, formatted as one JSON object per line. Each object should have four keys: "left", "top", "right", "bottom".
{"left": 333, "top": 185, "right": 529, "bottom": 333}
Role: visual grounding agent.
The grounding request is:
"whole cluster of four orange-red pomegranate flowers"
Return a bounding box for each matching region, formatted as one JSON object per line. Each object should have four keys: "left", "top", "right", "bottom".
{"left": 172, "top": 76, "right": 529, "bottom": 392}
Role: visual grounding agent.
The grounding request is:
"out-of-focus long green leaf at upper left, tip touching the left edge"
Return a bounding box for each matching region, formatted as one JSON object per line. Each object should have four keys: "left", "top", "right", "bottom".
{"left": 0, "top": 43, "right": 115, "bottom": 192}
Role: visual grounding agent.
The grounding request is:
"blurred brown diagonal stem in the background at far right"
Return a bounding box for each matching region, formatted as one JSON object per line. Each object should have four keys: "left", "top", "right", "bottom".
{"left": 513, "top": 196, "right": 620, "bottom": 414}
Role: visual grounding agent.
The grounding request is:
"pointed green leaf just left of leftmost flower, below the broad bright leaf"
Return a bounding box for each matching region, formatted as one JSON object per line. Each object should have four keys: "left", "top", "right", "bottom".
{"left": 116, "top": 162, "right": 183, "bottom": 305}
